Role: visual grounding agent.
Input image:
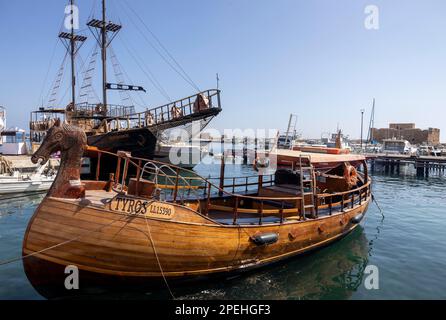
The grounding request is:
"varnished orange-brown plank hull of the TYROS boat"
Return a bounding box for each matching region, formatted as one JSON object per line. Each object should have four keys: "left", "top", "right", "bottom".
{"left": 23, "top": 192, "right": 370, "bottom": 288}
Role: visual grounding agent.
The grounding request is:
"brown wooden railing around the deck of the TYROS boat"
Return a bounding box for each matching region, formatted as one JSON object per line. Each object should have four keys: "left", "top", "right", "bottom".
{"left": 90, "top": 149, "right": 371, "bottom": 224}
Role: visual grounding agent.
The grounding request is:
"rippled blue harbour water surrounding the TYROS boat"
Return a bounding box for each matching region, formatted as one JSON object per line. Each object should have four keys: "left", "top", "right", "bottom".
{"left": 0, "top": 160, "right": 446, "bottom": 299}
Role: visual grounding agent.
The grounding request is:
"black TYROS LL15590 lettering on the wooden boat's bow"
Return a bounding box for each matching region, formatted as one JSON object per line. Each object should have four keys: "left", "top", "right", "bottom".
{"left": 110, "top": 197, "right": 175, "bottom": 219}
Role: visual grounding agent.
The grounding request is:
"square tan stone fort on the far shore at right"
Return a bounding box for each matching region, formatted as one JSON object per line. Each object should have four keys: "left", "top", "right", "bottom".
{"left": 372, "top": 123, "right": 440, "bottom": 145}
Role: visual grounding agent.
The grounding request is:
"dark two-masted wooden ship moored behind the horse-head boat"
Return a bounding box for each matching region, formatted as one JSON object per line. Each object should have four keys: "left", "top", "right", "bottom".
{"left": 30, "top": 0, "right": 221, "bottom": 158}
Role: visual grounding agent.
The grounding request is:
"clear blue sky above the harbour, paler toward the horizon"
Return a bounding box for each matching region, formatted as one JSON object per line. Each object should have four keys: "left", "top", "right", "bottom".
{"left": 0, "top": 0, "right": 446, "bottom": 141}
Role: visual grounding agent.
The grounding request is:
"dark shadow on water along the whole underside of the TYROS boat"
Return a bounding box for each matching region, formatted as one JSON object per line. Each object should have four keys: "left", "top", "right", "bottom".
{"left": 36, "top": 227, "right": 369, "bottom": 300}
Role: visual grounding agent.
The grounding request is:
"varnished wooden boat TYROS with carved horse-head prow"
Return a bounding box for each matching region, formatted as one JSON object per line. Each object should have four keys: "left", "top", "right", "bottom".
{"left": 23, "top": 122, "right": 371, "bottom": 292}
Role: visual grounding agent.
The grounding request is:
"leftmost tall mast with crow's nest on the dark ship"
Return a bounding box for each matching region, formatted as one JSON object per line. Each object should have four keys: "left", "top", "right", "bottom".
{"left": 59, "top": 0, "right": 87, "bottom": 106}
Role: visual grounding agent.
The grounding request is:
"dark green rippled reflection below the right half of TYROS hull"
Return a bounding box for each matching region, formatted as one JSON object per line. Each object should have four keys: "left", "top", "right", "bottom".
{"left": 175, "top": 228, "right": 369, "bottom": 299}
